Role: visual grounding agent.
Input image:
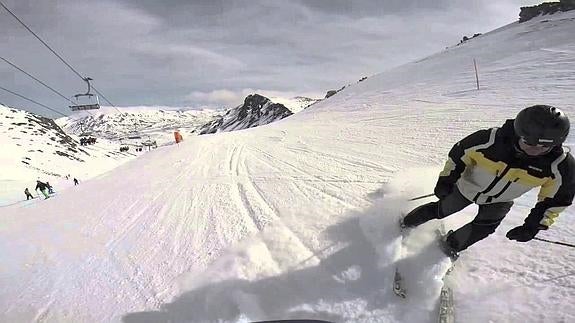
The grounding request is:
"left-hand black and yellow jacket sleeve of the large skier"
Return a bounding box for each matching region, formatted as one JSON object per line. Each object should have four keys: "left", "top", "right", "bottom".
{"left": 435, "top": 128, "right": 495, "bottom": 192}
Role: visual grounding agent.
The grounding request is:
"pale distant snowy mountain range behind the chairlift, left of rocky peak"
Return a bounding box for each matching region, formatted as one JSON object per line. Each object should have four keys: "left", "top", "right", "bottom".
{"left": 56, "top": 107, "right": 221, "bottom": 145}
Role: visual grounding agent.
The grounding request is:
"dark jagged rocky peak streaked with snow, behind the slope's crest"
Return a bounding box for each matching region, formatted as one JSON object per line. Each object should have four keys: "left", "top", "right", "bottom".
{"left": 199, "top": 94, "right": 301, "bottom": 135}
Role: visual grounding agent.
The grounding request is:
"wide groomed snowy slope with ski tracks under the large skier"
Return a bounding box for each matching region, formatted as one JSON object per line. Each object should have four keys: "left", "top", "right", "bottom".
{"left": 0, "top": 12, "right": 575, "bottom": 322}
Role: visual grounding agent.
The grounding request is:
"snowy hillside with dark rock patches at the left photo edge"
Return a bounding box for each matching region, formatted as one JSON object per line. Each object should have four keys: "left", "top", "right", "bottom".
{"left": 0, "top": 105, "right": 136, "bottom": 205}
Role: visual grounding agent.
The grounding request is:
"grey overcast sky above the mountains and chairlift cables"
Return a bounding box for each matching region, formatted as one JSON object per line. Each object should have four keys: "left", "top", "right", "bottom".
{"left": 0, "top": 0, "right": 542, "bottom": 117}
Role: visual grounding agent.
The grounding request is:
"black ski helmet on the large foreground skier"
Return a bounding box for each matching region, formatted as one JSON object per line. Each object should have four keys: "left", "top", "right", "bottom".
{"left": 513, "top": 105, "right": 569, "bottom": 147}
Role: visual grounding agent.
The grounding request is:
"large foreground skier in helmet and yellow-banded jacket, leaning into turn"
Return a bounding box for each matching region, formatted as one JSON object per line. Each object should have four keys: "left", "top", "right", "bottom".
{"left": 402, "top": 105, "right": 575, "bottom": 258}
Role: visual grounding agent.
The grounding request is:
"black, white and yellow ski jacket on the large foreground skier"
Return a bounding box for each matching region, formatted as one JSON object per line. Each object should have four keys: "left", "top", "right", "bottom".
{"left": 437, "top": 120, "right": 575, "bottom": 227}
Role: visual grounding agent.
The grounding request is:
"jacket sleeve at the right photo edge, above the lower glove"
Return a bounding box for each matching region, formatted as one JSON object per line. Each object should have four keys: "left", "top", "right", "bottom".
{"left": 525, "top": 153, "right": 575, "bottom": 229}
